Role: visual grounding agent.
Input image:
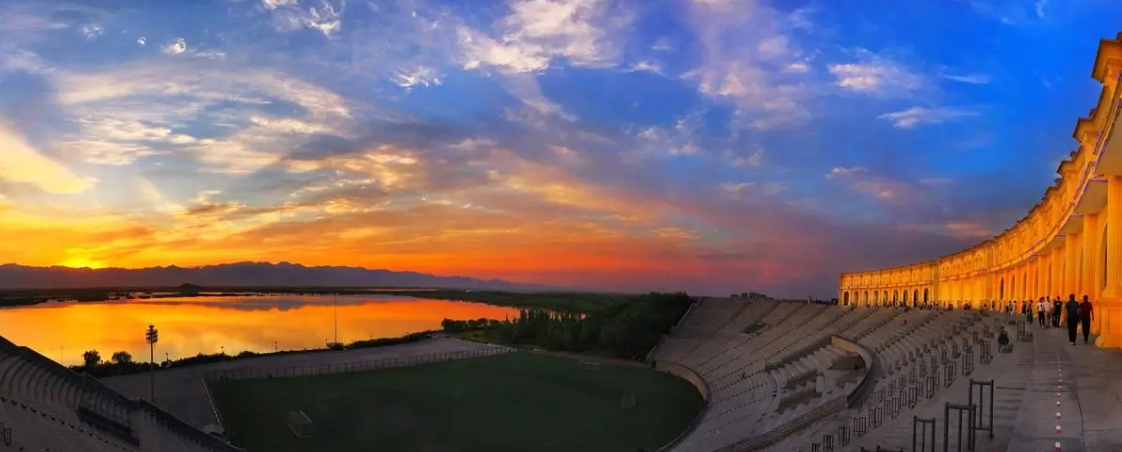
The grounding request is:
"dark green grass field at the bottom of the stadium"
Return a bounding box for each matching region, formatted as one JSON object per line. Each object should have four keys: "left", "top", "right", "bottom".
{"left": 212, "top": 352, "right": 702, "bottom": 452}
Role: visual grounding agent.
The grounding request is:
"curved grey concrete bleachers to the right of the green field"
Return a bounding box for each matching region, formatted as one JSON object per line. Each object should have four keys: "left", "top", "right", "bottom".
{"left": 652, "top": 298, "right": 997, "bottom": 452}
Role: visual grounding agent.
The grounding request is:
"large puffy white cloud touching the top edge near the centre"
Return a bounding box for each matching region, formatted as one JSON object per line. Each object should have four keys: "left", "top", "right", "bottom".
{"left": 459, "top": 0, "right": 632, "bottom": 72}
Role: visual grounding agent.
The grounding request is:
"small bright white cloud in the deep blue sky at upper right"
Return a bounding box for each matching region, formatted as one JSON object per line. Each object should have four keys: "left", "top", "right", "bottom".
{"left": 828, "top": 50, "right": 923, "bottom": 96}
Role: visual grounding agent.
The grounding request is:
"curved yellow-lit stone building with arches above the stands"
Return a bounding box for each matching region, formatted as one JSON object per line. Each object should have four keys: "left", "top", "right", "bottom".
{"left": 838, "top": 33, "right": 1122, "bottom": 348}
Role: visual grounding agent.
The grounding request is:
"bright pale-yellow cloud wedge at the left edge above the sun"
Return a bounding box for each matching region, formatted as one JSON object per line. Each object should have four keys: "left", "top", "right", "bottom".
{"left": 0, "top": 123, "right": 92, "bottom": 193}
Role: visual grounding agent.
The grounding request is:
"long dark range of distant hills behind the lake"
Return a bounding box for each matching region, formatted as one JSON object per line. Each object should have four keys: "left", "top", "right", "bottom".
{"left": 0, "top": 262, "right": 548, "bottom": 290}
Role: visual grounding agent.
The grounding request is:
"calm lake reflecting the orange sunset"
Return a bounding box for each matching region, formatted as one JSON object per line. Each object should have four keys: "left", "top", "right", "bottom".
{"left": 0, "top": 295, "right": 518, "bottom": 365}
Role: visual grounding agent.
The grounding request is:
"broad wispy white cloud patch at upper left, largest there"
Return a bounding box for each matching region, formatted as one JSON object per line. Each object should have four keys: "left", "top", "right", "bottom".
{"left": 55, "top": 58, "right": 351, "bottom": 173}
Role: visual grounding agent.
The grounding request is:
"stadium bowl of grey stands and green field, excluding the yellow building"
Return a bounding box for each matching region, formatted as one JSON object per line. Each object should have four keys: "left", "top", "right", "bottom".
{"left": 0, "top": 298, "right": 1119, "bottom": 452}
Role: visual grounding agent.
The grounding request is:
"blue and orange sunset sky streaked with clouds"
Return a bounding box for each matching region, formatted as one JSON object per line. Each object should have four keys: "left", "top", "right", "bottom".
{"left": 0, "top": 0, "right": 1122, "bottom": 296}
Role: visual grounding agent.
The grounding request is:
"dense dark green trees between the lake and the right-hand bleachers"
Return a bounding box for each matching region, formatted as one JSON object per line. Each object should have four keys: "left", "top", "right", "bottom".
{"left": 441, "top": 293, "right": 693, "bottom": 360}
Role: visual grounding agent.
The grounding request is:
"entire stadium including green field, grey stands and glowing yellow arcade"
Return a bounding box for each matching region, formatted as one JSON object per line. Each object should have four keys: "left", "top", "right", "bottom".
{"left": 0, "top": 15, "right": 1122, "bottom": 452}
